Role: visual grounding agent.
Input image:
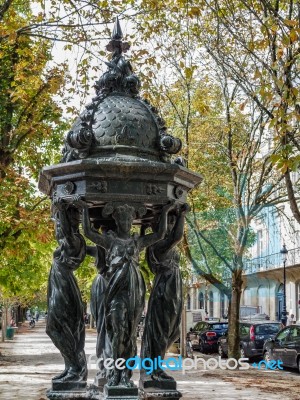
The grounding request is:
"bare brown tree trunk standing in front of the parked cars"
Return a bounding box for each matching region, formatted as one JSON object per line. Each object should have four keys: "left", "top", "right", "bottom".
{"left": 228, "top": 269, "right": 243, "bottom": 360}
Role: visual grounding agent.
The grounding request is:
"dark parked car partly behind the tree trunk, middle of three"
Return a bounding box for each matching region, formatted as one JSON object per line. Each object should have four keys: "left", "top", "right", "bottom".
{"left": 218, "top": 321, "right": 281, "bottom": 359}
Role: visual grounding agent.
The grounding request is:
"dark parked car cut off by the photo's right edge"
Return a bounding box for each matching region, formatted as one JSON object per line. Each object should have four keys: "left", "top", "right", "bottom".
{"left": 263, "top": 325, "right": 300, "bottom": 373}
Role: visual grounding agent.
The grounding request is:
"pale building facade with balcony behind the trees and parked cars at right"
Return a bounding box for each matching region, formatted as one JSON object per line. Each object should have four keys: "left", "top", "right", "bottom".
{"left": 186, "top": 205, "right": 300, "bottom": 329}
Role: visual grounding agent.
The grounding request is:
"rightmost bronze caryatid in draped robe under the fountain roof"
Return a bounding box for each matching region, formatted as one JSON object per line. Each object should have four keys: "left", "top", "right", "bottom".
{"left": 141, "top": 204, "right": 188, "bottom": 381}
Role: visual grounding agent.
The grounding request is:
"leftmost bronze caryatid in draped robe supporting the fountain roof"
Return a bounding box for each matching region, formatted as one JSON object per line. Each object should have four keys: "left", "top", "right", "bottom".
{"left": 46, "top": 199, "right": 87, "bottom": 387}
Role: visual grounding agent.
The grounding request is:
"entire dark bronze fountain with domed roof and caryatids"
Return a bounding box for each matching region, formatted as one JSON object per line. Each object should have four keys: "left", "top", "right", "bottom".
{"left": 39, "top": 16, "right": 202, "bottom": 400}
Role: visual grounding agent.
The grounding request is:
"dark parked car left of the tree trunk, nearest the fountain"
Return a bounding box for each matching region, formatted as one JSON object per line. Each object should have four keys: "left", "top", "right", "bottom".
{"left": 189, "top": 321, "right": 228, "bottom": 353}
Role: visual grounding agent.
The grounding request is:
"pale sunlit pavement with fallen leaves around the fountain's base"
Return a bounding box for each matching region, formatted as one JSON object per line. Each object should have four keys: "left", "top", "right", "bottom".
{"left": 0, "top": 321, "right": 300, "bottom": 400}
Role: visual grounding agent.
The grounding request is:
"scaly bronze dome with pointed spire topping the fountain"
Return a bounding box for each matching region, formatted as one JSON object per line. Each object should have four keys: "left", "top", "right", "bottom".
{"left": 62, "top": 19, "right": 181, "bottom": 162}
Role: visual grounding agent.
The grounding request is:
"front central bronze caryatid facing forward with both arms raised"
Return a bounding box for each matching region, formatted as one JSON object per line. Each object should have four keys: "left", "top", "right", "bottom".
{"left": 83, "top": 200, "right": 173, "bottom": 387}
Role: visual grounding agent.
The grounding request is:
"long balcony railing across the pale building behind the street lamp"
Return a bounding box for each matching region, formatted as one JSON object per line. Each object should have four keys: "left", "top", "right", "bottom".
{"left": 244, "top": 247, "right": 300, "bottom": 274}
